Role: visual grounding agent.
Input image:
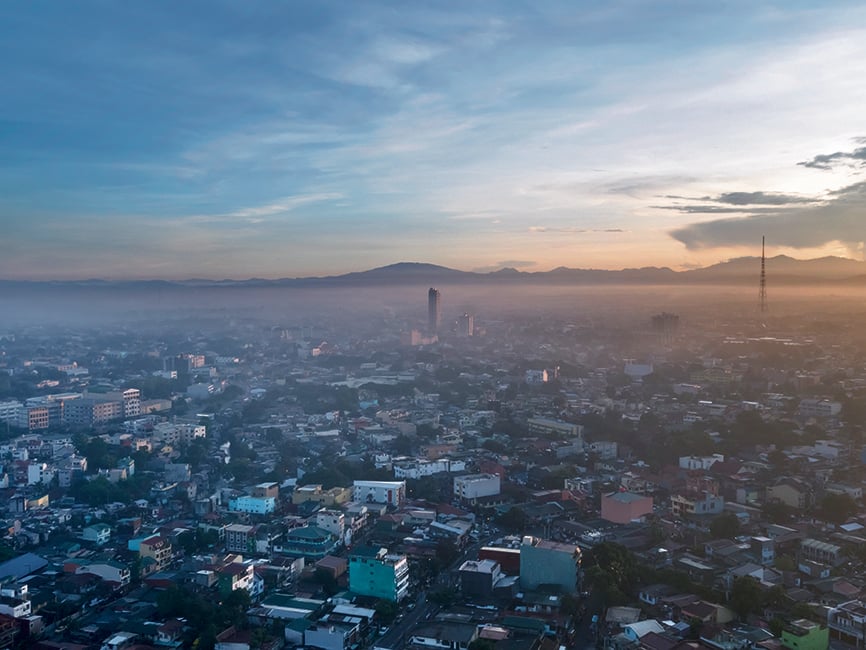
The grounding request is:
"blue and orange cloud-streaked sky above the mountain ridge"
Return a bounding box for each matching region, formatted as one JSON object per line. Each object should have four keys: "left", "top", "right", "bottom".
{"left": 0, "top": 0, "right": 866, "bottom": 279}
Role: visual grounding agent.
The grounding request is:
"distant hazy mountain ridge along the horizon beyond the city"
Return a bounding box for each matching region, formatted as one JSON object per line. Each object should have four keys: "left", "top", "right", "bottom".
{"left": 0, "top": 255, "right": 866, "bottom": 289}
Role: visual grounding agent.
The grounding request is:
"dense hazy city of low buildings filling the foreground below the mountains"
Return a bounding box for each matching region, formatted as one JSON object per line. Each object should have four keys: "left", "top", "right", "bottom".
{"left": 0, "top": 272, "right": 866, "bottom": 650}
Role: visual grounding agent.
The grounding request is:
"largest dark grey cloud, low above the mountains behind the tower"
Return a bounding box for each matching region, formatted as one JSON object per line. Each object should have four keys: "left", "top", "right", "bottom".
{"left": 670, "top": 182, "right": 866, "bottom": 250}
